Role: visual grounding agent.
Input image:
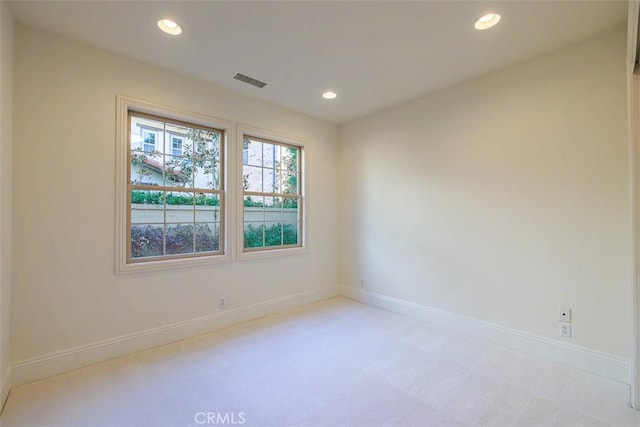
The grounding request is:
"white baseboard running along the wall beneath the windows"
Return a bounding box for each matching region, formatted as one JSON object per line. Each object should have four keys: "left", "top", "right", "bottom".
{"left": 11, "top": 286, "right": 339, "bottom": 392}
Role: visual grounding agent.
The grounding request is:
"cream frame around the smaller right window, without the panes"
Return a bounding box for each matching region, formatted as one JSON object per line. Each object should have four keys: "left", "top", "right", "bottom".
{"left": 235, "top": 124, "right": 309, "bottom": 260}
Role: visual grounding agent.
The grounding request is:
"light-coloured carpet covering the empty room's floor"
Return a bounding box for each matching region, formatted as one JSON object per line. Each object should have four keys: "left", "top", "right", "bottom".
{"left": 2, "top": 298, "right": 640, "bottom": 427}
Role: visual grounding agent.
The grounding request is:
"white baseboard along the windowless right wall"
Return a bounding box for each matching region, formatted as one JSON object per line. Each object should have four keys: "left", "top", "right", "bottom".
{"left": 340, "top": 287, "right": 631, "bottom": 384}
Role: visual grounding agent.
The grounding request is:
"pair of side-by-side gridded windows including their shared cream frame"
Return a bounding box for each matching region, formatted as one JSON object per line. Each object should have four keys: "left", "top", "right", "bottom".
{"left": 115, "top": 96, "right": 306, "bottom": 274}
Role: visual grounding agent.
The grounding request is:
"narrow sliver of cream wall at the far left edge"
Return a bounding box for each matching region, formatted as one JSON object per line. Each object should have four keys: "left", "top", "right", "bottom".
{"left": 0, "top": 1, "right": 13, "bottom": 405}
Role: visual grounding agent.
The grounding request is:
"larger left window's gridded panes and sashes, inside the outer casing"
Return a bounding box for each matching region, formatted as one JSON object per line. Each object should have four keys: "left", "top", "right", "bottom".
{"left": 126, "top": 110, "right": 225, "bottom": 264}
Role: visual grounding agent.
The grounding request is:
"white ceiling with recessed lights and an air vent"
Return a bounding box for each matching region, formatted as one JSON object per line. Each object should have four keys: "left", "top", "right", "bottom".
{"left": 12, "top": 0, "right": 627, "bottom": 123}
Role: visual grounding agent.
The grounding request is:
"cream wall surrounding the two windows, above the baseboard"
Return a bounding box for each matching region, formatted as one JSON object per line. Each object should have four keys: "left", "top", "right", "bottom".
{"left": 11, "top": 25, "right": 337, "bottom": 372}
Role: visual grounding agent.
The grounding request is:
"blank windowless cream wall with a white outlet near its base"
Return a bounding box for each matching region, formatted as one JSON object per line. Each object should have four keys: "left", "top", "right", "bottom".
{"left": 338, "top": 28, "right": 632, "bottom": 359}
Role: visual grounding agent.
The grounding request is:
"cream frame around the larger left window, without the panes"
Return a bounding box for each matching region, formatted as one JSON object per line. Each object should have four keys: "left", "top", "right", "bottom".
{"left": 115, "top": 96, "right": 236, "bottom": 274}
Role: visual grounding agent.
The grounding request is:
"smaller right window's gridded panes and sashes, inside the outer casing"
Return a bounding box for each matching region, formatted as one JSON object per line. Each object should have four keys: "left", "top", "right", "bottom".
{"left": 242, "top": 134, "right": 303, "bottom": 252}
